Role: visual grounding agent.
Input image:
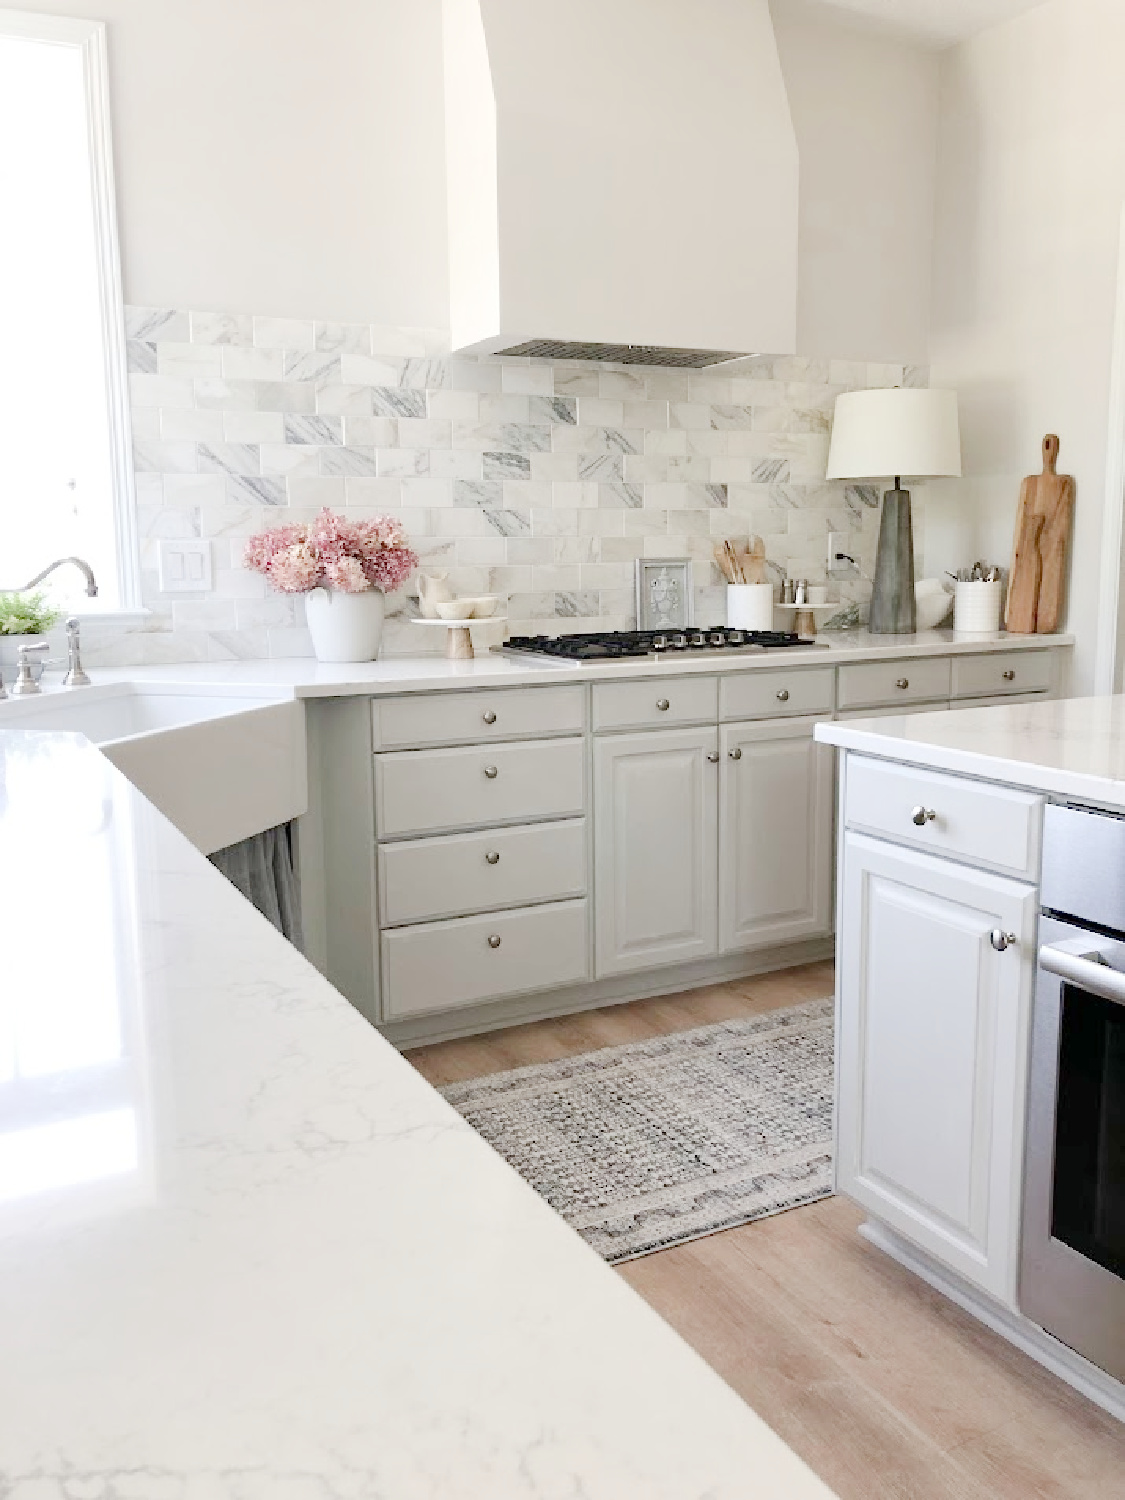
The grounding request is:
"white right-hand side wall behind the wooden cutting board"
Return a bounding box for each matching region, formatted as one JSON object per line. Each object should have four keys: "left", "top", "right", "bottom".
{"left": 926, "top": 0, "right": 1125, "bottom": 692}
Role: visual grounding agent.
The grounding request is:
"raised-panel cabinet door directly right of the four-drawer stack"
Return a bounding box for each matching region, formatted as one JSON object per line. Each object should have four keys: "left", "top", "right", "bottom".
{"left": 594, "top": 729, "right": 719, "bottom": 977}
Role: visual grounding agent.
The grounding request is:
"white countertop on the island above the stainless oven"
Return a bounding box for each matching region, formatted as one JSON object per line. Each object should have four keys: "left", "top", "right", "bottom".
{"left": 816, "top": 696, "right": 1125, "bottom": 810}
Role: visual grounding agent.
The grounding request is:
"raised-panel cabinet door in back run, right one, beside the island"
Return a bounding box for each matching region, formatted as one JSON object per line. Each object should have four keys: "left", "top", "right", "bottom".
{"left": 719, "top": 719, "right": 833, "bottom": 953}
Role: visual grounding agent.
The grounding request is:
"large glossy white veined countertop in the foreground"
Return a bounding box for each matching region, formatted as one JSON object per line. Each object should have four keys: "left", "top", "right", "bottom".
{"left": 0, "top": 723, "right": 830, "bottom": 1500}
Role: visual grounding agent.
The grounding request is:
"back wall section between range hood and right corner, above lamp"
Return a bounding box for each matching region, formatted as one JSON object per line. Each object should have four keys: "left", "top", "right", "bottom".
{"left": 771, "top": 0, "right": 939, "bottom": 365}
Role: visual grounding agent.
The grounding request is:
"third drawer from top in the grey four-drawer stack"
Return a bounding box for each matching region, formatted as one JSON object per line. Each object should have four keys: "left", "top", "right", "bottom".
{"left": 380, "top": 818, "right": 587, "bottom": 927}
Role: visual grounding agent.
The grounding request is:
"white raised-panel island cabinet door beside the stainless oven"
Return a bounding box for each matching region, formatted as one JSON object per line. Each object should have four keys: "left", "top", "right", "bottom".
{"left": 836, "top": 833, "right": 1035, "bottom": 1305}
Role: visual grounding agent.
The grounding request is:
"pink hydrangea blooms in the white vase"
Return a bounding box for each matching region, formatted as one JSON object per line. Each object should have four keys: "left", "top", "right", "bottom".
{"left": 243, "top": 509, "right": 419, "bottom": 594}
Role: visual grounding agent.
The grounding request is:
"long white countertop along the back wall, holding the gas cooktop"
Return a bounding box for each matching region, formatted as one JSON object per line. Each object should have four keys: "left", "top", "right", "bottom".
{"left": 83, "top": 630, "right": 1074, "bottom": 698}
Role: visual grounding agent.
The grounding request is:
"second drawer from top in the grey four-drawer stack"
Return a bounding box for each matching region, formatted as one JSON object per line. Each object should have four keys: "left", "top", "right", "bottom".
{"left": 375, "top": 740, "right": 587, "bottom": 839}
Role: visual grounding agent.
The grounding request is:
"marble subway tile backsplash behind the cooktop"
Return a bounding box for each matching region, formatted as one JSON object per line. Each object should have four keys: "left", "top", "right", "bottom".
{"left": 89, "top": 308, "right": 927, "bottom": 666}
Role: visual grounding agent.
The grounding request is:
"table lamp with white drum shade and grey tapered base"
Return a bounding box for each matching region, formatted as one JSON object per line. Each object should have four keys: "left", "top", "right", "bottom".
{"left": 827, "top": 389, "right": 962, "bottom": 635}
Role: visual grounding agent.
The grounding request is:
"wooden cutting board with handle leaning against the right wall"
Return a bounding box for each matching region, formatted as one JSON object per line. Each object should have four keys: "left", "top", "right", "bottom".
{"left": 1005, "top": 434, "right": 1076, "bottom": 636}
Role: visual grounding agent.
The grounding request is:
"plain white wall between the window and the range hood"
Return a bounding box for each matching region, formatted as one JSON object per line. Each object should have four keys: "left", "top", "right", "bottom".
{"left": 11, "top": 0, "right": 449, "bottom": 327}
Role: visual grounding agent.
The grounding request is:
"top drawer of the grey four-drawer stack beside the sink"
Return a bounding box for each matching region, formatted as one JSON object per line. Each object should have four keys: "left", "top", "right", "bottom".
{"left": 371, "top": 683, "right": 587, "bottom": 750}
